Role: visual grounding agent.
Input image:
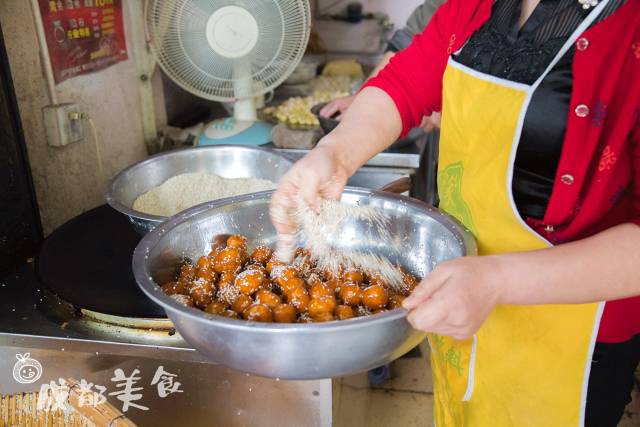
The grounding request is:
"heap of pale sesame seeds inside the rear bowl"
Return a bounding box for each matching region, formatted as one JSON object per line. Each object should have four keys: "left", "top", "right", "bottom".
{"left": 133, "top": 173, "right": 276, "bottom": 216}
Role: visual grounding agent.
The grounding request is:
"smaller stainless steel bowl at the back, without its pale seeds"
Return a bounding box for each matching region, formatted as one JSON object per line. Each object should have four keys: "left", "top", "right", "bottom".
{"left": 105, "top": 145, "right": 293, "bottom": 234}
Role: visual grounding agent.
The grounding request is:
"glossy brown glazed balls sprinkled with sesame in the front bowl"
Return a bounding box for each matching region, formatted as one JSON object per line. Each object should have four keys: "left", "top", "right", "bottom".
{"left": 161, "top": 235, "right": 418, "bottom": 323}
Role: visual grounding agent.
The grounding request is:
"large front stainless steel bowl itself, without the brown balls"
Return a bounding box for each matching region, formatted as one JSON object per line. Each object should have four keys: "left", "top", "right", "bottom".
{"left": 133, "top": 188, "right": 476, "bottom": 379}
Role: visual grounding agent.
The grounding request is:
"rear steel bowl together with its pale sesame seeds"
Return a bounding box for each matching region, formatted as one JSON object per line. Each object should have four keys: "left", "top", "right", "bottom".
{"left": 105, "top": 145, "right": 293, "bottom": 234}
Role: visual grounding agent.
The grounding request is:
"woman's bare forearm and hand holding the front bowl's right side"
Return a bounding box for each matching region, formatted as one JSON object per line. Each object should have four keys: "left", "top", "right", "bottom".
{"left": 404, "top": 224, "right": 640, "bottom": 339}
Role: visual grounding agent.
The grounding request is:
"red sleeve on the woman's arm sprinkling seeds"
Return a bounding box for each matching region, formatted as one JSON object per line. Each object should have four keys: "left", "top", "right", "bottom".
{"left": 364, "top": 0, "right": 492, "bottom": 135}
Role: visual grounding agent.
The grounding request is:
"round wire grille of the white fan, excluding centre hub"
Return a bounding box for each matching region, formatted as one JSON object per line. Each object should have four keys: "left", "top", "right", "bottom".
{"left": 146, "top": 0, "right": 311, "bottom": 101}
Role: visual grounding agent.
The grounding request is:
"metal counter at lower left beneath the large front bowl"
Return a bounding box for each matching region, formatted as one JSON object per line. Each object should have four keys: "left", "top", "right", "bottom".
{"left": 0, "top": 264, "right": 332, "bottom": 427}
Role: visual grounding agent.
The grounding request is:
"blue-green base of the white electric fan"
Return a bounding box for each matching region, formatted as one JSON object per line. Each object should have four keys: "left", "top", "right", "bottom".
{"left": 198, "top": 117, "right": 272, "bottom": 146}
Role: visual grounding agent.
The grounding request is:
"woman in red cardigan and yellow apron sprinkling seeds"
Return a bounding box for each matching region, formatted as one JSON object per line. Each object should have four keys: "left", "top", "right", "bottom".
{"left": 272, "top": 0, "right": 640, "bottom": 427}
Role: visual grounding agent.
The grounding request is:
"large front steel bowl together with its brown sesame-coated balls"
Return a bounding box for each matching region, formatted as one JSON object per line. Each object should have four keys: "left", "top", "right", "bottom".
{"left": 133, "top": 188, "right": 476, "bottom": 379}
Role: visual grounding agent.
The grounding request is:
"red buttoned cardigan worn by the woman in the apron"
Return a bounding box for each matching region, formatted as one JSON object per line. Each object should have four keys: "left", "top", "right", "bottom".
{"left": 367, "top": 0, "right": 640, "bottom": 342}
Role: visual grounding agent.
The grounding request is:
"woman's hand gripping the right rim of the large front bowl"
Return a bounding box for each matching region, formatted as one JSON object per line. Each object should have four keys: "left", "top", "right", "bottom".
{"left": 403, "top": 257, "right": 505, "bottom": 340}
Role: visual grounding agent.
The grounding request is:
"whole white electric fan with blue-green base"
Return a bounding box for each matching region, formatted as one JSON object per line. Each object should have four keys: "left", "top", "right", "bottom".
{"left": 146, "top": 0, "right": 311, "bottom": 145}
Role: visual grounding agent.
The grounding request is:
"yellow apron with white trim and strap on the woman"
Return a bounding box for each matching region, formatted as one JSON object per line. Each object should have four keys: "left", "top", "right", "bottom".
{"left": 429, "top": 1, "right": 607, "bottom": 427}
